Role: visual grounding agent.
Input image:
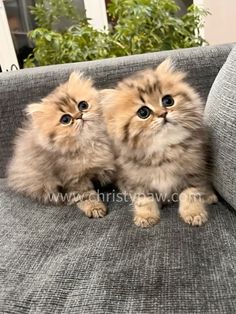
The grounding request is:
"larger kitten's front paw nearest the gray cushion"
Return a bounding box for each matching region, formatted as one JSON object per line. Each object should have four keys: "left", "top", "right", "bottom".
{"left": 179, "top": 203, "right": 208, "bottom": 226}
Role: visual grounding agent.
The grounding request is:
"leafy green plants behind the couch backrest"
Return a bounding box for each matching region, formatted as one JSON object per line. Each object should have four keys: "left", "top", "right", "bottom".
{"left": 25, "top": 0, "right": 208, "bottom": 67}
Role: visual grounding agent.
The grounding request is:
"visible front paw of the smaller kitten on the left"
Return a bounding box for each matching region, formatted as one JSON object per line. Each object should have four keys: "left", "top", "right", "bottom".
{"left": 78, "top": 201, "right": 107, "bottom": 218}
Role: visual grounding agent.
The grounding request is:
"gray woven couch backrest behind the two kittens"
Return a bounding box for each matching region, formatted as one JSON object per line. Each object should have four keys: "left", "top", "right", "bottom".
{"left": 0, "top": 45, "right": 232, "bottom": 177}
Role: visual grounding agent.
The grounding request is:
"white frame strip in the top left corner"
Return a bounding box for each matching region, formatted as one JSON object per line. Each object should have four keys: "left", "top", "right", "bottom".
{"left": 0, "top": 0, "right": 19, "bottom": 72}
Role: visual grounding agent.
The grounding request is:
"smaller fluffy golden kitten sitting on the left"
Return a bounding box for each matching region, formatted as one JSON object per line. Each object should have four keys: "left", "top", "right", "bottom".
{"left": 8, "top": 72, "right": 115, "bottom": 217}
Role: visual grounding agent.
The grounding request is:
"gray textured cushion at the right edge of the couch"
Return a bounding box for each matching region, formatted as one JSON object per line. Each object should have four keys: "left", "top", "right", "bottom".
{"left": 205, "top": 46, "right": 236, "bottom": 209}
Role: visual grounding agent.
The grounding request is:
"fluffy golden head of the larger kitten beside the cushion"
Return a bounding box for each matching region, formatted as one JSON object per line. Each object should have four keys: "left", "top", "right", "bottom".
{"left": 104, "top": 60, "right": 202, "bottom": 151}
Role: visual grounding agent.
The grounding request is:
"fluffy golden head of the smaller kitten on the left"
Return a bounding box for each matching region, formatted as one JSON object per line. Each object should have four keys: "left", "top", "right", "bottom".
{"left": 26, "top": 73, "right": 101, "bottom": 151}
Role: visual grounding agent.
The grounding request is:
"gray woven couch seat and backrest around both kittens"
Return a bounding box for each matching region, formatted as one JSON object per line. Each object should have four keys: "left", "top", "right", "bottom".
{"left": 0, "top": 45, "right": 236, "bottom": 314}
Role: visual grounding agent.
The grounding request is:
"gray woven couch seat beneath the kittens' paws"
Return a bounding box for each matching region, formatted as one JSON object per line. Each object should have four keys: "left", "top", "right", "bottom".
{"left": 0, "top": 180, "right": 236, "bottom": 314}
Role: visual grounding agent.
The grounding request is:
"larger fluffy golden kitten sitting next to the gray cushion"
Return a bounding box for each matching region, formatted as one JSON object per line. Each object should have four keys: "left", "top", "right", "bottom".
{"left": 103, "top": 59, "right": 216, "bottom": 227}
